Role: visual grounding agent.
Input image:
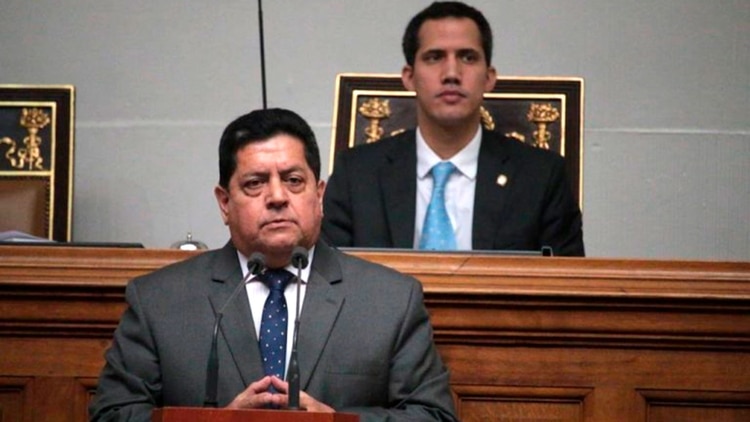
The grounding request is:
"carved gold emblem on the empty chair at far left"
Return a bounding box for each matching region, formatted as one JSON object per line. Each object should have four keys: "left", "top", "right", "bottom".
{"left": 0, "top": 108, "right": 50, "bottom": 170}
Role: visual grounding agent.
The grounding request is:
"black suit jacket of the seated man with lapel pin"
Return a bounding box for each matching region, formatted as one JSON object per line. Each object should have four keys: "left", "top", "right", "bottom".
{"left": 323, "top": 130, "right": 584, "bottom": 256}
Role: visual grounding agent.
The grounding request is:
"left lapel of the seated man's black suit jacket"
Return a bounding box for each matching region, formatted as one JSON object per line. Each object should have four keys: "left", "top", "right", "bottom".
{"left": 379, "top": 130, "right": 417, "bottom": 248}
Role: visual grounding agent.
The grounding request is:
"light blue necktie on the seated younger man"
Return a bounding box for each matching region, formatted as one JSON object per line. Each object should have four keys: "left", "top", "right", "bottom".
{"left": 419, "top": 161, "right": 456, "bottom": 251}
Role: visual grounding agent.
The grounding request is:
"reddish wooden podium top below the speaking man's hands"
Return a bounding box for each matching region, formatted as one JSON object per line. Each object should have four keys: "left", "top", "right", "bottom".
{"left": 151, "top": 407, "right": 359, "bottom": 422}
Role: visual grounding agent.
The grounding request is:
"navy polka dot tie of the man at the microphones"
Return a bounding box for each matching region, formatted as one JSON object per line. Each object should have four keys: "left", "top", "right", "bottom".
{"left": 258, "top": 269, "right": 294, "bottom": 379}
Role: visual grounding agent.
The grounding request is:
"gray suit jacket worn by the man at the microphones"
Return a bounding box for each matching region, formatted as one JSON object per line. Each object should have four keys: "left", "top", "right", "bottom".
{"left": 90, "top": 242, "right": 455, "bottom": 421}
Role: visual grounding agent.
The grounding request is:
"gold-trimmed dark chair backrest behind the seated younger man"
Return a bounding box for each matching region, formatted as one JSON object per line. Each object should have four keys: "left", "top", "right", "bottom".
{"left": 330, "top": 73, "right": 584, "bottom": 208}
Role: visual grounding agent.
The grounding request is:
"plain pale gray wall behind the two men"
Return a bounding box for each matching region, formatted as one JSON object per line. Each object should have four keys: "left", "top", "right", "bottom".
{"left": 0, "top": 0, "right": 750, "bottom": 261}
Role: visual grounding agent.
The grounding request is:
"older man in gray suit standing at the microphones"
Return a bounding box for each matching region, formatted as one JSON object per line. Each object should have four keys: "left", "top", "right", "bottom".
{"left": 90, "top": 109, "right": 456, "bottom": 421}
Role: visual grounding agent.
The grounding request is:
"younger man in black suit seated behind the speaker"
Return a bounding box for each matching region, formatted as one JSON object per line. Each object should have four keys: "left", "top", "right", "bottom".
{"left": 323, "top": 2, "right": 584, "bottom": 256}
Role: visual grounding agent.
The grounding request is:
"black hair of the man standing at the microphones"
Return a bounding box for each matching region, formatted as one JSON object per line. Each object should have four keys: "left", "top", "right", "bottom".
{"left": 219, "top": 108, "right": 320, "bottom": 189}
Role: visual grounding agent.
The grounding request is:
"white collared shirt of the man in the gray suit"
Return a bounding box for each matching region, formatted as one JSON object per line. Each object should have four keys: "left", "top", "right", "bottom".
{"left": 237, "top": 246, "right": 315, "bottom": 376}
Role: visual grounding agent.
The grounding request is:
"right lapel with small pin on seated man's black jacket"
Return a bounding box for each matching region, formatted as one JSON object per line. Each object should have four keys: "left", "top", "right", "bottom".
{"left": 472, "top": 130, "right": 515, "bottom": 250}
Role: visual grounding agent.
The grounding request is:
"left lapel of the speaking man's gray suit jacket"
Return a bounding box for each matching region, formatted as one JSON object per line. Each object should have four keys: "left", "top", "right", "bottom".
{"left": 209, "top": 244, "right": 263, "bottom": 385}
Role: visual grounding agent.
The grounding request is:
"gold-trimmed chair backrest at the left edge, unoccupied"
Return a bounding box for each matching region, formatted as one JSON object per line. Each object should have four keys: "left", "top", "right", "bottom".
{"left": 0, "top": 85, "right": 74, "bottom": 242}
